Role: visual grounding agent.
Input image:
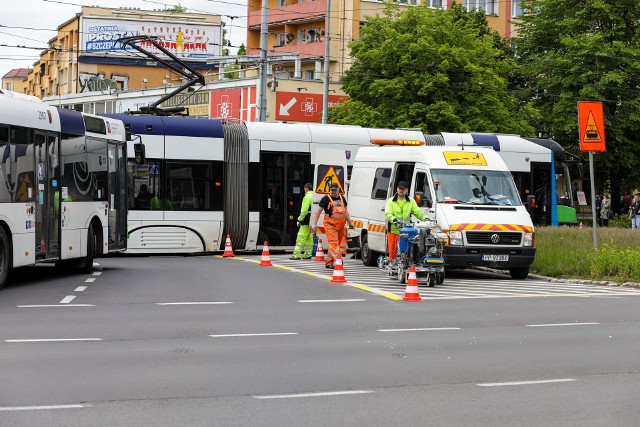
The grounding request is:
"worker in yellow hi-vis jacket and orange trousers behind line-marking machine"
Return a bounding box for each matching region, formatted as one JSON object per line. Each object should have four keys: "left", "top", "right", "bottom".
{"left": 384, "top": 181, "right": 427, "bottom": 260}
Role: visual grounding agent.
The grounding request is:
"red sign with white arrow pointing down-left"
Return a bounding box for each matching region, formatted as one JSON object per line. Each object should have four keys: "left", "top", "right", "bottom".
{"left": 276, "top": 92, "right": 349, "bottom": 123}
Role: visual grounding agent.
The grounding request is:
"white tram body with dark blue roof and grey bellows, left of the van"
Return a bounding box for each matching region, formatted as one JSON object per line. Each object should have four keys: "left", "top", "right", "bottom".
{"left": 107, "top": 114, "right": 421, "bottom": 253}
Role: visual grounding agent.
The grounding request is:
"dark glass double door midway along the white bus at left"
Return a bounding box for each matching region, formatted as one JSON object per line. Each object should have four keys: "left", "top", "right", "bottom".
{"left": 34, "top": 133, "right": 64, "bottom": 260}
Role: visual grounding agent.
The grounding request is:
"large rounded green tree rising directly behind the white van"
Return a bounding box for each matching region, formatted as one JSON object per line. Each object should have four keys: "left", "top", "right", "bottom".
{"left": 329, "top": 5, "right": 537, "bottom": 135}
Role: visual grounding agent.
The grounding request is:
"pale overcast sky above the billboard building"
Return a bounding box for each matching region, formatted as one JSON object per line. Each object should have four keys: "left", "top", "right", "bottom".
{"left": 0, "top": 0, "right": 247, "bottom": 77}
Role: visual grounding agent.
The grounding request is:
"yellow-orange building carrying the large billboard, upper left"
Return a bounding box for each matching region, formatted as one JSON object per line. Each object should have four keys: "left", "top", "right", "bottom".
{"left": 24, "top": 6, "right": 222, "bottom": 98}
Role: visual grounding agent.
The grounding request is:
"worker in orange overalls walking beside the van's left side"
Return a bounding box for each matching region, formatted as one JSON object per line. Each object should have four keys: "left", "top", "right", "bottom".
{"left": 311, "top": 183, "right": 353, "bottom": 268}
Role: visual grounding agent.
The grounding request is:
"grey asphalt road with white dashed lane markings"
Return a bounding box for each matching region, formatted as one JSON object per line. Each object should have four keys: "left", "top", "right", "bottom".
{"left": 0, "top": 256, "right": 640, "bottom": 426}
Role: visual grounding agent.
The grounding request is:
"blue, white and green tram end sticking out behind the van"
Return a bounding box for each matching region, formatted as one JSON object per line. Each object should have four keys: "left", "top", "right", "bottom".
{"left": 425, "top": 132, "right": 582, "bottom": 226}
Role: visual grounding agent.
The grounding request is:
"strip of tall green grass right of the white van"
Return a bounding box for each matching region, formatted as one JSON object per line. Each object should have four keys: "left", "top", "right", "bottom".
{"left": 531, "top": 226, "right": 640, "bottom": 282}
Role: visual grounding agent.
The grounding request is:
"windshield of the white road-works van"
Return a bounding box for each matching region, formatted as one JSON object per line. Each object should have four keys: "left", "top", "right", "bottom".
{"left": 431, "top": 169, "right": 522, "bottom": 206}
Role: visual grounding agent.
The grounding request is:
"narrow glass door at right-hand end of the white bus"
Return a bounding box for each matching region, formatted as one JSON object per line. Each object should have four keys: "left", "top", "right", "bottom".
{"left": 107, "top": 141, "right": 127, "bottom": 251}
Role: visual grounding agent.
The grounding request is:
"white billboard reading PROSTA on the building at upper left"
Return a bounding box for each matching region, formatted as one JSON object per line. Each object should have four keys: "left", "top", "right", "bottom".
{"left": 80, "top": 18, "right": 222, "bottom": 62}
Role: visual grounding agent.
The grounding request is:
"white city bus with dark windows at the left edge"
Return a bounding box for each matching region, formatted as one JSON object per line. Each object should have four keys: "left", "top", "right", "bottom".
{"left": 0, "top": 91, "right": 127, "bottom": 288}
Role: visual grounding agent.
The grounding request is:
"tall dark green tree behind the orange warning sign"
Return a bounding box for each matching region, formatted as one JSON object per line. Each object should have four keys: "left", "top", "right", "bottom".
{"left": 515, "top": 0, "right": 640, "bottom": 202}
